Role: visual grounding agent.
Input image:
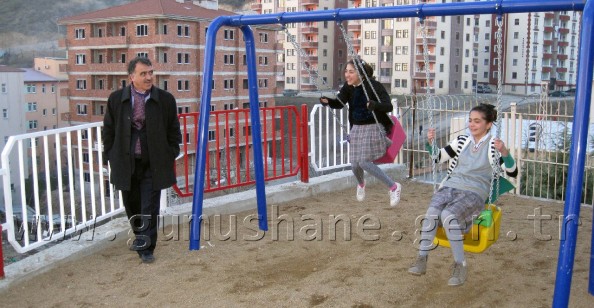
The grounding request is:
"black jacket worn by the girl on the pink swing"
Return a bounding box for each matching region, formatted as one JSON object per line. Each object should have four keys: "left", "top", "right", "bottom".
{"left": 327, "top": 78, "right": 394, "bottom": 134}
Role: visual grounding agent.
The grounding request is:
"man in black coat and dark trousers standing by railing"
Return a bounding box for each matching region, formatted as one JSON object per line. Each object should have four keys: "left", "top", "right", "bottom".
{"left": 103, "top": 57, "right": 182, "bottom": 263}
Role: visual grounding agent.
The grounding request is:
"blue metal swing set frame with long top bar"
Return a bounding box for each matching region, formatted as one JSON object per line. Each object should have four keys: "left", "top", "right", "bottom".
{"left": 189, "top": 0, "right": 594, "bottom": 307}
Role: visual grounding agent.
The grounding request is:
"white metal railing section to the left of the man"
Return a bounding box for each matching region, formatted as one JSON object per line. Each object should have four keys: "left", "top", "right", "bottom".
{"left": 0, "top": 122, "right": 124, "bottom": 253}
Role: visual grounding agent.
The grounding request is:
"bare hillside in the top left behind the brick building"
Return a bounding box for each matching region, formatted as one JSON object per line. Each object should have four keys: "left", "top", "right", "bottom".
{"left": 0, "top": 0, "right": 245, "bottom": 67}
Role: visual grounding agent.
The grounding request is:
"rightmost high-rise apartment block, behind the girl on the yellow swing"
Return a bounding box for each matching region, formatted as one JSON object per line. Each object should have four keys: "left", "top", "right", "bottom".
{"left": 478, "top": 11, "right": 581, "bottom": 95}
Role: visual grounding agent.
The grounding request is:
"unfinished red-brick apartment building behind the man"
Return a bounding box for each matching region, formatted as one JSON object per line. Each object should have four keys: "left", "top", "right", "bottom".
{"left": 58, "top": 0, "right": 282, "bottom": 190}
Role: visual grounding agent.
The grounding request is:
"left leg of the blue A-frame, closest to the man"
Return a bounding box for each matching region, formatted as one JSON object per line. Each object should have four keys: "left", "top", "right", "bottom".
{"left": 190, "top": 16, "right": 228, "bottom": 250}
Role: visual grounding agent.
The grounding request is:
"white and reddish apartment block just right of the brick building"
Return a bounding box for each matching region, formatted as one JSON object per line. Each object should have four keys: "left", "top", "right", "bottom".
{"left": 251, "top": 0, "right": 350, "bottom": 91}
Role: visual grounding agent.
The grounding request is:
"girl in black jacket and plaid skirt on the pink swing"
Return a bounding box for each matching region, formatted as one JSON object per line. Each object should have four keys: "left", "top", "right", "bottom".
{"left": 320, "top": 59, "right": 402, "bottom": 206}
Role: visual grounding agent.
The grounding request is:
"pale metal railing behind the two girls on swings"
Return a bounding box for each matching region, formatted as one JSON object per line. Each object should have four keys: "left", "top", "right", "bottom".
{"left": 309, "top": 95, "right": 594, "bottom": 205}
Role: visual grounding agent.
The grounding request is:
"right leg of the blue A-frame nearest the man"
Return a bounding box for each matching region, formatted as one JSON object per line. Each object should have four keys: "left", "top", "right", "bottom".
{"left": 241, "top": 26, "right": 268, "bottom": 231}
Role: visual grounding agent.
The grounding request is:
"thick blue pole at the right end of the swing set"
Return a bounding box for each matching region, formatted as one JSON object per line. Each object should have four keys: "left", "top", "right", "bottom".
{"left": 553, "top": 0, "right": 594, "bottom": 307}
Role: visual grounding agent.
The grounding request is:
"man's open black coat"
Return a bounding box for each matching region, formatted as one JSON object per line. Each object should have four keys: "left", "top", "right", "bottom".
{"left": 103, "top": 86, "right": 182, "bottom": 190}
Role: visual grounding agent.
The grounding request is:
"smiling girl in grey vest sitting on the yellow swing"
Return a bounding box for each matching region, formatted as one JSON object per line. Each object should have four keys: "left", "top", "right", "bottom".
{"left": 408, "top": 104, "right": 518, "bottom": 286}
